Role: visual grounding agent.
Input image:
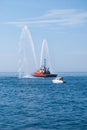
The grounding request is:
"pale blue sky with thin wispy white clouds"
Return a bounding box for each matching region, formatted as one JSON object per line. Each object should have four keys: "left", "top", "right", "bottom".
{"left": 0, "top": 0, "right": 87, "bottom": 72}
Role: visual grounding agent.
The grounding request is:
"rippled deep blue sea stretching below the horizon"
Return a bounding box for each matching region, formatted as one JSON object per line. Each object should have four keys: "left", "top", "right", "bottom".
{"left": 0, "top": 73, "right": 87, "bottom": 130}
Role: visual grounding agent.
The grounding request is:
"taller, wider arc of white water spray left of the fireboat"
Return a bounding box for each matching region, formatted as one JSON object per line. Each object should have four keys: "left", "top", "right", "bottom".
{"left": 19, "top": 26, "right": 37, "bottom": 78}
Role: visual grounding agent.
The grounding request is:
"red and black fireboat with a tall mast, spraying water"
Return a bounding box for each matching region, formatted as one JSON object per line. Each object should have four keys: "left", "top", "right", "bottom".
{"left": 33, "top": 59, "right": 57, "bottom": 78}
